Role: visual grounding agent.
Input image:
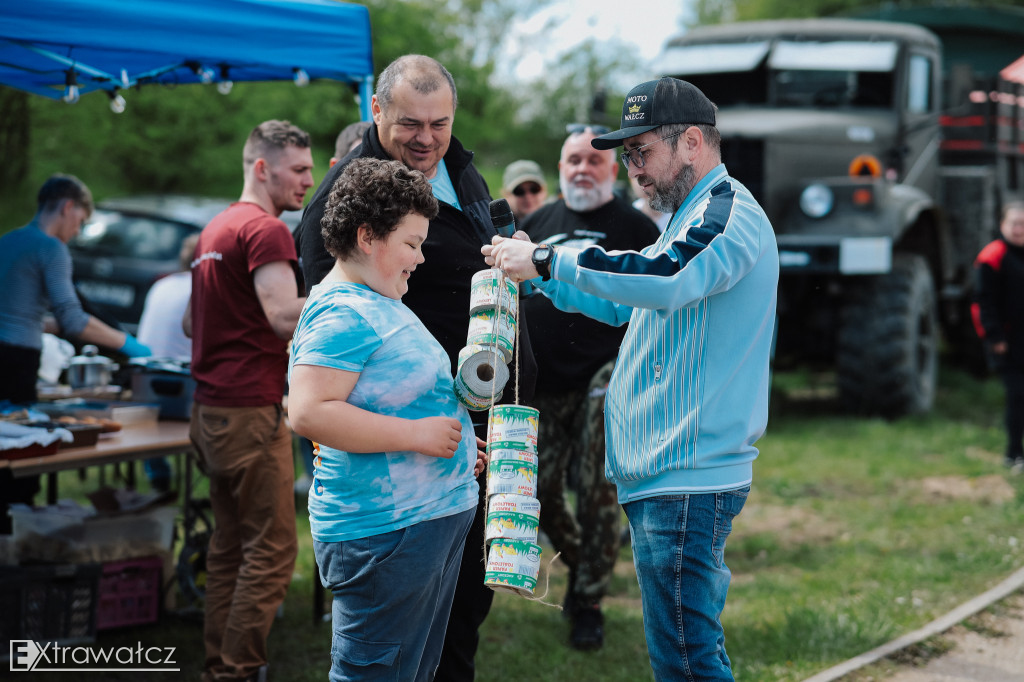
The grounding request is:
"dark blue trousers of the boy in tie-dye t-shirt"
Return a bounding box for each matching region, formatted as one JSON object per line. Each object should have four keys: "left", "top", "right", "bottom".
{"left": 313, "top": 509, "right": 473, "bottom": 682}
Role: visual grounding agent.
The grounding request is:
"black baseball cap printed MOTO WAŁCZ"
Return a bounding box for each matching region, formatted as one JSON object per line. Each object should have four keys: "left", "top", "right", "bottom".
{"left": 590, "top": 76, "right": 715, "bottom": 150}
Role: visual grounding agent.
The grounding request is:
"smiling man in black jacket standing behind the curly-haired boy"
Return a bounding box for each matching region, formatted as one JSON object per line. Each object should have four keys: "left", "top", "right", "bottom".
{"left": 296, "top": 54, "right": 537, "bottom": 682}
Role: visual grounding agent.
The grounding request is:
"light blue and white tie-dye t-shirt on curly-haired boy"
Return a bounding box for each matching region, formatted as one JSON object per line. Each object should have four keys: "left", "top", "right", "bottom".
{"left": 291, "top": 282, "right": 478, "bottom": 542}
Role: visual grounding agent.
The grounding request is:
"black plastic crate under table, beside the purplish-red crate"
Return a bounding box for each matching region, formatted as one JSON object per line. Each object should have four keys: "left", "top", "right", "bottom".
{"left": 0, "top": 563, "right": 102, "bottom": 657}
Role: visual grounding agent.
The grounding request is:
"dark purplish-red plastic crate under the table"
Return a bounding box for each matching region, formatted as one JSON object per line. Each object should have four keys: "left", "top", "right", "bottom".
{"left": 96, "top": 556, "right": 164, "bottom": 630}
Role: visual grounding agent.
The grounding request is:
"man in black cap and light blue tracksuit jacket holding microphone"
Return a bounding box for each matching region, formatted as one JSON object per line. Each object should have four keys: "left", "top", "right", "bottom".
{"left": 482, "top": 78, "right": 778, "bottom": 680}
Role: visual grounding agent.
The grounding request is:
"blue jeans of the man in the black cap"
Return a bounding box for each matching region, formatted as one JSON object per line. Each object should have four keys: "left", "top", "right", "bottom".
{"left": 623, "top": 487, "right": 751, "bottom": 682}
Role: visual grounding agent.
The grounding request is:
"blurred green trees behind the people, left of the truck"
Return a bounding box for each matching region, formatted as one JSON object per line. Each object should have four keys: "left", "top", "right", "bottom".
{"left": 0, "top": 0, "right": 655, "bottom": 230}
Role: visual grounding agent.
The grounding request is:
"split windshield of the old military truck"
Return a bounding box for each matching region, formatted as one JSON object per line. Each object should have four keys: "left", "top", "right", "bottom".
{"left": 659, "top": 40, "right": 897, "bottom": 108}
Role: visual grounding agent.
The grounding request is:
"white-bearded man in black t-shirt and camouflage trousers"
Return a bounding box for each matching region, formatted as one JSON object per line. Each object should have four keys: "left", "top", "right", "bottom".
{"left": 522, "top": 124, "right": 658, "bottom": 649}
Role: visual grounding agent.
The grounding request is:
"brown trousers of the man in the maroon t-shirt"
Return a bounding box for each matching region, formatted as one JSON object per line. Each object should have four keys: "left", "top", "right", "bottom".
{"left": 189, "top": 402, "right": 298, "bottom": 681}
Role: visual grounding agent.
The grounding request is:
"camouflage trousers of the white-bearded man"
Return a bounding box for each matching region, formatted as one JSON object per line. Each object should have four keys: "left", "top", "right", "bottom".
{"left": 532, "top": 361, "right": 622, "bottom": 605}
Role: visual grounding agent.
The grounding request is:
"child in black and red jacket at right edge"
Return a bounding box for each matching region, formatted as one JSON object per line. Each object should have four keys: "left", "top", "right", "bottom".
{"left": 972, "top": 202, "right": 1024, "bottom": 471}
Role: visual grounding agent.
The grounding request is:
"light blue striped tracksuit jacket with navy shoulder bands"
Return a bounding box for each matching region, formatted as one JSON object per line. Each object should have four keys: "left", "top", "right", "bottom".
{"left": 531, "top": 165, "right": 778, "bottom": 504}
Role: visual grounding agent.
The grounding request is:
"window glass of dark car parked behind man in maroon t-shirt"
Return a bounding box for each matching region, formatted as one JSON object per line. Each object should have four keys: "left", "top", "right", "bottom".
{"left": 68, "top": 211, "right": 196, "bottom": 260}
